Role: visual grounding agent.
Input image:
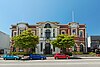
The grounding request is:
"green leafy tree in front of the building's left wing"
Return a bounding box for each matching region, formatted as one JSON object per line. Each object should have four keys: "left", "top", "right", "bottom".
{"left": 12, "top": 29, "right": 39, "bottom": 53}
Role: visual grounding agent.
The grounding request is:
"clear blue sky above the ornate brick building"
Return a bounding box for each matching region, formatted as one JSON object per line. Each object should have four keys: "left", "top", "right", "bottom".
{"left": 0, "top": 0, "right": 100, "bottom": 36}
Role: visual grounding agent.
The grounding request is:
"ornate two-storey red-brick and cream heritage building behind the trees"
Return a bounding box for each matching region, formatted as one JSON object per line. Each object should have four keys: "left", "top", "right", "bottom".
{"left": 11, "top": 21, "right": 86, "bottom": 54}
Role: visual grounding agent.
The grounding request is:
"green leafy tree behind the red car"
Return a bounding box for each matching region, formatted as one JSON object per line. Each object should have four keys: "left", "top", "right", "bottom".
{"left": 51, "top": 34, "right": 75, "bottom": 53}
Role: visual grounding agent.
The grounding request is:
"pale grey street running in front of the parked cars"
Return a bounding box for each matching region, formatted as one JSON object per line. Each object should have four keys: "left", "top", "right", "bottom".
{"left": 0, "top": 59, "right": 100, "bottom": 67}
